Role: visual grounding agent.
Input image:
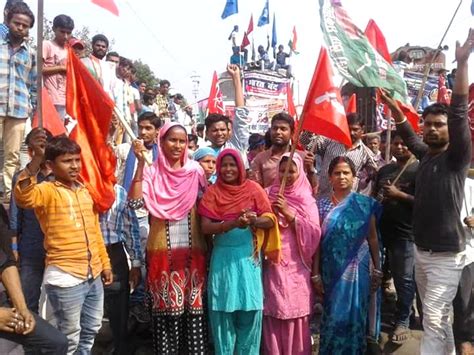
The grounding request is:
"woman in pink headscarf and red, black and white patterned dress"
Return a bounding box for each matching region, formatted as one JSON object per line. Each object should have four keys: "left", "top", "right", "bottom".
{"left": 129, "top": 123, "right": 207, "bottom": 354}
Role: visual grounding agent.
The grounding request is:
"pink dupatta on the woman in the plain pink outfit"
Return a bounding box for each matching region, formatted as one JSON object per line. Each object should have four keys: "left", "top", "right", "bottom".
{"left": 267, "top": 153, "right": 321, "bottom": 271}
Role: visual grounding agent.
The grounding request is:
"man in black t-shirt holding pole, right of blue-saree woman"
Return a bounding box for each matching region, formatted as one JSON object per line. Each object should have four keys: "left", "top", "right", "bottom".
{"left": 373, "top": 132, "right": 418, "bottom": 344}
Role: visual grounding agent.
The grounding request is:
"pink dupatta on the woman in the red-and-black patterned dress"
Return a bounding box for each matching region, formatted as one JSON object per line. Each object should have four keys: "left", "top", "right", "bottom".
{"left": 143, "top": 122, "right": 206, "bottom": 221}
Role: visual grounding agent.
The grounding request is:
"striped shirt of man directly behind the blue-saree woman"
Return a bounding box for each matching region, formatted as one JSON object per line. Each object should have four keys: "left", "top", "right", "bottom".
{"left": 312, "top": 136, "right": 377, "bottom": 196}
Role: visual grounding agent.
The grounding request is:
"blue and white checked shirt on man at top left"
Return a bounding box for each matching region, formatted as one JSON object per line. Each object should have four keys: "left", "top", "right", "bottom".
{"left": 0, "top": 37, "right": 36, "bottom": 119}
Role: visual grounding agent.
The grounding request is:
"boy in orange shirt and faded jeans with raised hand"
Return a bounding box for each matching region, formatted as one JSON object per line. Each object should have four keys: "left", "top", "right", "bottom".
{"left": 14, "top": 130, "right": 113, "bottom": 353}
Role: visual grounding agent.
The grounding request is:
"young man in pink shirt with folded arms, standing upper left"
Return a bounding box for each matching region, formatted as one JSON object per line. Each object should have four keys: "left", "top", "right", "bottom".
{"left": 43, "top": 15, "right": 74, "bottom": 120}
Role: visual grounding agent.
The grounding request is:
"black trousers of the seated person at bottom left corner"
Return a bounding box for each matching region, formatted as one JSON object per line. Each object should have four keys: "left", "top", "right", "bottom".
{"left": 0, "top": 313, "right": 68, "bottom": 355}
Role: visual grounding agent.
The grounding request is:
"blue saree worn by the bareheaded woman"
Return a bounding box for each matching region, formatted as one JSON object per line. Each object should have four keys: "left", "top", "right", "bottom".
{"left": 319, "top": 193, "right": 380, "bottom": 355}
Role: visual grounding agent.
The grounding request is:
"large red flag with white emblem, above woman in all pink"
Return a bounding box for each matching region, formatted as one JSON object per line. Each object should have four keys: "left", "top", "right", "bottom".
{"left": 302, "top": 47, "right": 352, "bottom": 147}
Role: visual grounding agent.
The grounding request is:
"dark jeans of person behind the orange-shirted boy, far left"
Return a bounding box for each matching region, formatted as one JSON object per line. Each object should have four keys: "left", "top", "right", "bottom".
{"left": 20, "top": 257, "right": 44, "bottom": 313}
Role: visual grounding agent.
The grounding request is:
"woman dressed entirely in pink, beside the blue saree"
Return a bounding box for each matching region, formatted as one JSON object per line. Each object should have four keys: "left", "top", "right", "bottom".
{"left": 263, "top": 153, "right": 321, "bottom": 354}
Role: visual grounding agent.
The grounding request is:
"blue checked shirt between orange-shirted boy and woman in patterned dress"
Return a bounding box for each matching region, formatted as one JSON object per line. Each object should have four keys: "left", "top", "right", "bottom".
{"left": 99, "top": 185, "right": 143, "bottom": 267}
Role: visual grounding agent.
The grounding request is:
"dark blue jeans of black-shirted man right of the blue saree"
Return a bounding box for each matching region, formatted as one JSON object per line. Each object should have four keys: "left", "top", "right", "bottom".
{"left": 387, "top": 240, "right": 415, "bottom": 327}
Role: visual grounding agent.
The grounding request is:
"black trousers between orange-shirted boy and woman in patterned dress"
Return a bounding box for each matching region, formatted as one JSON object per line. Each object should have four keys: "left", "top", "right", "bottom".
{"left": 104, "top": 243, "right": 130, "bottom": 354}
